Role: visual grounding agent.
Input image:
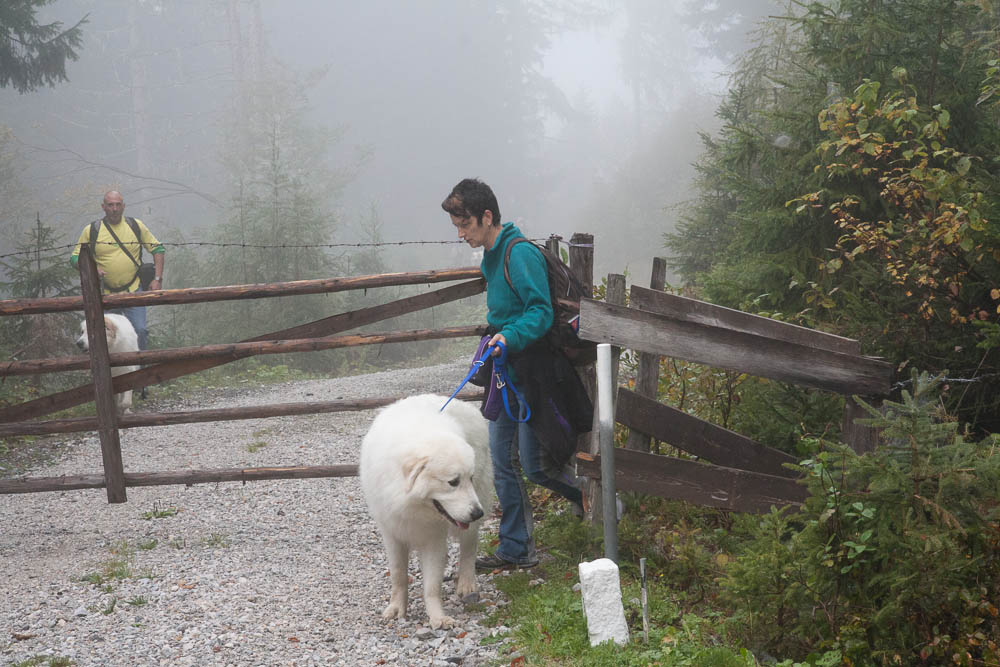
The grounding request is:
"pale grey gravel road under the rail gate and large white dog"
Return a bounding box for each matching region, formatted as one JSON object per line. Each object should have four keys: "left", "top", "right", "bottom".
{"left": 0, "top": 360, "right": 509, "bottom": 666}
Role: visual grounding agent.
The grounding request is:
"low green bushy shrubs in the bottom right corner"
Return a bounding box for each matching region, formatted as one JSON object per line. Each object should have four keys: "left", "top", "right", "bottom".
{"left": 724, "top": 373, "right": 1000, "bottom": 664}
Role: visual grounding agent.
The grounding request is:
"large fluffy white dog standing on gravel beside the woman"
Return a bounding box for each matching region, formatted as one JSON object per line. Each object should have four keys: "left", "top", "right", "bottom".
{"left": 360, "top": 394, "right": 493, "bottom": 629}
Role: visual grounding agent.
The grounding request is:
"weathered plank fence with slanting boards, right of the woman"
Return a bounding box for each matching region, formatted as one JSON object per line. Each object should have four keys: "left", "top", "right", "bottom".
{"left": 577, "top": 260, "right": 892, "bottom": 512}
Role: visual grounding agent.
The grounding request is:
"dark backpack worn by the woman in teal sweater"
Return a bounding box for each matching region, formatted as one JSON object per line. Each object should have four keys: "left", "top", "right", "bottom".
{"left": 503, "top": 237, "right": 597, "bottom": 366}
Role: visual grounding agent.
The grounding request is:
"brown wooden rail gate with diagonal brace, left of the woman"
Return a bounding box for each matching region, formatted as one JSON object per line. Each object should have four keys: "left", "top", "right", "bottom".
{"left": 0, "top": 247, "right": 498, "bottom": 503}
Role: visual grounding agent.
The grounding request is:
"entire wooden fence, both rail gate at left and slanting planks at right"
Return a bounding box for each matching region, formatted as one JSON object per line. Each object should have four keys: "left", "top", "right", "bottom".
{"left": 0, "top": 243, "right": 891, "bottom": 518}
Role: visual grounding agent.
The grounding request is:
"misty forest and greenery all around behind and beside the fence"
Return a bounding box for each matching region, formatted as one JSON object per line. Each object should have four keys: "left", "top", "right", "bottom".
{"left": 0, "top": 0, "right": 1000, "bottom": 666}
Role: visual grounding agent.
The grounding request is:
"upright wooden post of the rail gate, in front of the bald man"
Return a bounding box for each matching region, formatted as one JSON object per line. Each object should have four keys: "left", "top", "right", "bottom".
{"left": 79, "top": 245, "right": 127, "bottom": 503}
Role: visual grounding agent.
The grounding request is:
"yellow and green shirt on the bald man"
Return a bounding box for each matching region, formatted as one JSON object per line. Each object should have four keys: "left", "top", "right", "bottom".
{"left": 70, "top": 215, "right": 166, "bottom": 294}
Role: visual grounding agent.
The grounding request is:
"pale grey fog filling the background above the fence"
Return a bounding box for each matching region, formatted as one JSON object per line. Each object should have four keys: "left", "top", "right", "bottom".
{"left": 0, "top": 0, "right": 770, "bottom": 287}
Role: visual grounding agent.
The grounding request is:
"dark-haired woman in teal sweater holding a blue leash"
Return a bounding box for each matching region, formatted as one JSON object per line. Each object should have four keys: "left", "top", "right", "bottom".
{"left": 441, "top": 178, "right": 583, "bottom": 570}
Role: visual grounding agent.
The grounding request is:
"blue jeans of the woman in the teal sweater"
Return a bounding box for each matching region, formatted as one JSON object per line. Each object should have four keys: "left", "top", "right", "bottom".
{"left": 489, "top": 400, "right": 583, "bottom": 564}
